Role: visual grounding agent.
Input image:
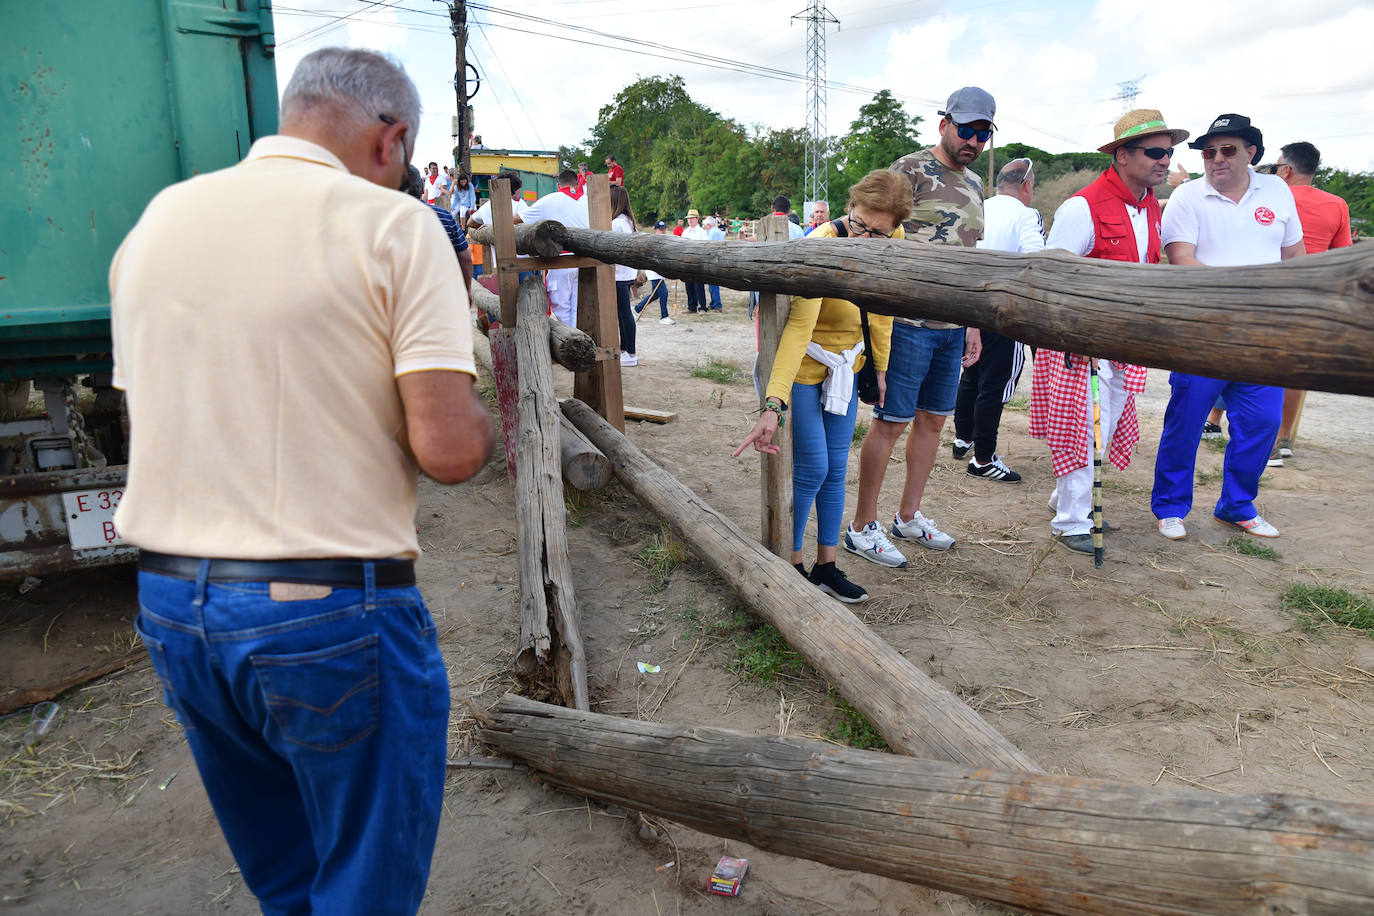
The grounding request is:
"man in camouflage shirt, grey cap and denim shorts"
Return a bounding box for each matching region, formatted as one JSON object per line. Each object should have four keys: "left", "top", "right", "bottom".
{"left": 845, "top": 87, "right": 996, "bottom": 566}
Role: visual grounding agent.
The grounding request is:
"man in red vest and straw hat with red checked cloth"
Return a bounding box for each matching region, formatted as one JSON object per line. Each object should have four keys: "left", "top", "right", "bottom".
{"left": 1031, "top": 108, "right": 1189, "bottom": 553}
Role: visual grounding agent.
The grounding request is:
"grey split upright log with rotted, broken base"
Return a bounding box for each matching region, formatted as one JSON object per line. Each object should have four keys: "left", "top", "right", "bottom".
{"left": 515, "top": 277, "right": 588, "bottom": 710}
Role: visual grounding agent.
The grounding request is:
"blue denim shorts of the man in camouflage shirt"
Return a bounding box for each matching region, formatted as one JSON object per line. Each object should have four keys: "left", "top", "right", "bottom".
{"left": 872, "top": 321, "right": 963, "bottom": 423}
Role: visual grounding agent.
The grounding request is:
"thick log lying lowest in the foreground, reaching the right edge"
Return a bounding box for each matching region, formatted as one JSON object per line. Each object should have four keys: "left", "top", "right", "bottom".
{"left": 478, "top": 695, "right": 1374, "bottom": 915}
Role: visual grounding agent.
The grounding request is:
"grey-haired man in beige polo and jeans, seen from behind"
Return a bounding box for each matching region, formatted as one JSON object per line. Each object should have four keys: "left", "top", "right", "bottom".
{"left": 110, "top": 48, "right": 492, "bottom": 913}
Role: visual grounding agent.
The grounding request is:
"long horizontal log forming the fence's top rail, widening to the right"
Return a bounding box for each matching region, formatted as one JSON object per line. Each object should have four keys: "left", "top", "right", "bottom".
{"left": 517, "top": 221, "right": 1374, "bottom": 394}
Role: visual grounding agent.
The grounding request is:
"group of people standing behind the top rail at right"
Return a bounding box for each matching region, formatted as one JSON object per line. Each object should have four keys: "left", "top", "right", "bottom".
{"left": 736, "top": 87, "right": 1351, "bottom": 602}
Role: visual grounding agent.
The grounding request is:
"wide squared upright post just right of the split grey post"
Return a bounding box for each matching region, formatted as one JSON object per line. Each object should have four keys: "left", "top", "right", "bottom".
{"left": 571, "top": 174, "right": 625, "bottom": 433}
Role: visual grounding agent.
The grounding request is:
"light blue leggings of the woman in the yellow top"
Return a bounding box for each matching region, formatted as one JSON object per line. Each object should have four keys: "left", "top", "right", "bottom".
{"left": 787, "top": 383, "right": 859, "bottom": 551}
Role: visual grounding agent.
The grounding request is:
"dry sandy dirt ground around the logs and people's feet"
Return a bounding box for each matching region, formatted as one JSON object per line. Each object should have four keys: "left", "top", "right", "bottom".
{"left": 0, "top": 284, "right": 1374, "bottom": 915}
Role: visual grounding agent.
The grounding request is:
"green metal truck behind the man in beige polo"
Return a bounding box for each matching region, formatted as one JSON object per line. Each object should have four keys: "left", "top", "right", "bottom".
{"left": 0, "top": 0, "right": 278, "bottom": 578}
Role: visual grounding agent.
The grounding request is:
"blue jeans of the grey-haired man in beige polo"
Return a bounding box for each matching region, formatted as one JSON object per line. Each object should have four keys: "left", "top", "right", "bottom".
{"left": 136, "top": 564, "right": 449, "bottom": 915}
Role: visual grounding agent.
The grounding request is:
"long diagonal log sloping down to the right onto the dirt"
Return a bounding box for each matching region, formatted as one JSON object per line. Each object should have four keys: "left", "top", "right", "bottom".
{"left": 562, "top": 398, "right": 1040, "bottom": 772}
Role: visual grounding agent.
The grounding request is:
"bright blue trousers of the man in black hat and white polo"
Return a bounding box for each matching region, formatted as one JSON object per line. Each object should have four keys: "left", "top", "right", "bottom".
{"left": 1150, "top": 372, "right": 1283, "bottom": 522}
